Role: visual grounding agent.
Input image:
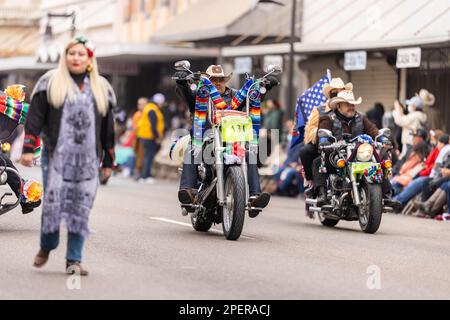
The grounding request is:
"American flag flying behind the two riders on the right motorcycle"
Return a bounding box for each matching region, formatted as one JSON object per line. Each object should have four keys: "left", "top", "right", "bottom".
{"left": 291, "top": 74, "right": 331, "bottom": 148}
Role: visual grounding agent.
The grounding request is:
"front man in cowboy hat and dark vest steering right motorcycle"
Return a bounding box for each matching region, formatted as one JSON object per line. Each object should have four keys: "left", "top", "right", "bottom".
{"left": 313, "top": 90, "right": 397, "bottom": 207}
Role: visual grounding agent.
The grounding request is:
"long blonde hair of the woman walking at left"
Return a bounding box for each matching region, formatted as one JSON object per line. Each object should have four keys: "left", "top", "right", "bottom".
{"left": 47, "top": 40, "right": 112, "bottom": 116}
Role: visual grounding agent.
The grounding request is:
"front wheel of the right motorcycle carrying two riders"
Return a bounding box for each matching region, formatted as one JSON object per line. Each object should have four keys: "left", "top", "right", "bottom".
{"left": 359, "top": 183, "right": 383, "bottom": 234}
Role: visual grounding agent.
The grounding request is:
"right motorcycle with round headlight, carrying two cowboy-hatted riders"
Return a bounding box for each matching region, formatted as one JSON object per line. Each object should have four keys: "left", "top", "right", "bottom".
{"left": 306, "top": 129, "right": 392, "bottom": 234}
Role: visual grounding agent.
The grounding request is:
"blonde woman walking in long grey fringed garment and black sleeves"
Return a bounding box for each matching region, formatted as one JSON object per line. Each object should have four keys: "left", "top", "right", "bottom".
{"left": 22, "top": 37, "right": 116, "bottom": 276}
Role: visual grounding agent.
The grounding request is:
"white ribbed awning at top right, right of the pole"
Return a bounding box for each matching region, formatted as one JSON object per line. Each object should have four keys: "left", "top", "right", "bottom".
{"left": 295, "top": 0, "right": 450, "bottom": 53}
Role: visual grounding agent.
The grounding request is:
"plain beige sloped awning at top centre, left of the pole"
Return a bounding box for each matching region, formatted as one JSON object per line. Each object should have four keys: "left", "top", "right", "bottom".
{"left": 151, "top": 0, "right": 292, "bottom": 45}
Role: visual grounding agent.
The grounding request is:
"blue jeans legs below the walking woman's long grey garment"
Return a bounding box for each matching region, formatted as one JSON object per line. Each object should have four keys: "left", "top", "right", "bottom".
{"left": 41, "top": 231, "right": 85, "bottom": 262}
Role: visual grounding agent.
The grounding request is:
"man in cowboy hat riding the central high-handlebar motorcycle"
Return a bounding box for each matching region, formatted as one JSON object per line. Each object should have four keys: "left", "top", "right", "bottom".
{"left": 174, "top": 65, "right": 279, "bottom": 218}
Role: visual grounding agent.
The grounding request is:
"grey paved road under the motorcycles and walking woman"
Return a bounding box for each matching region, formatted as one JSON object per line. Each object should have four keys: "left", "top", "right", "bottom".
{"left": 0, "top": 165, "right": 450, "bottom": 299}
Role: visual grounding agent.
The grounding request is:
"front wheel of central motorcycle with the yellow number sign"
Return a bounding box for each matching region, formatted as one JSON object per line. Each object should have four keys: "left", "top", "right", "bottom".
{"left": 222, "top": 166, "right": 246, "bottom": 240}
